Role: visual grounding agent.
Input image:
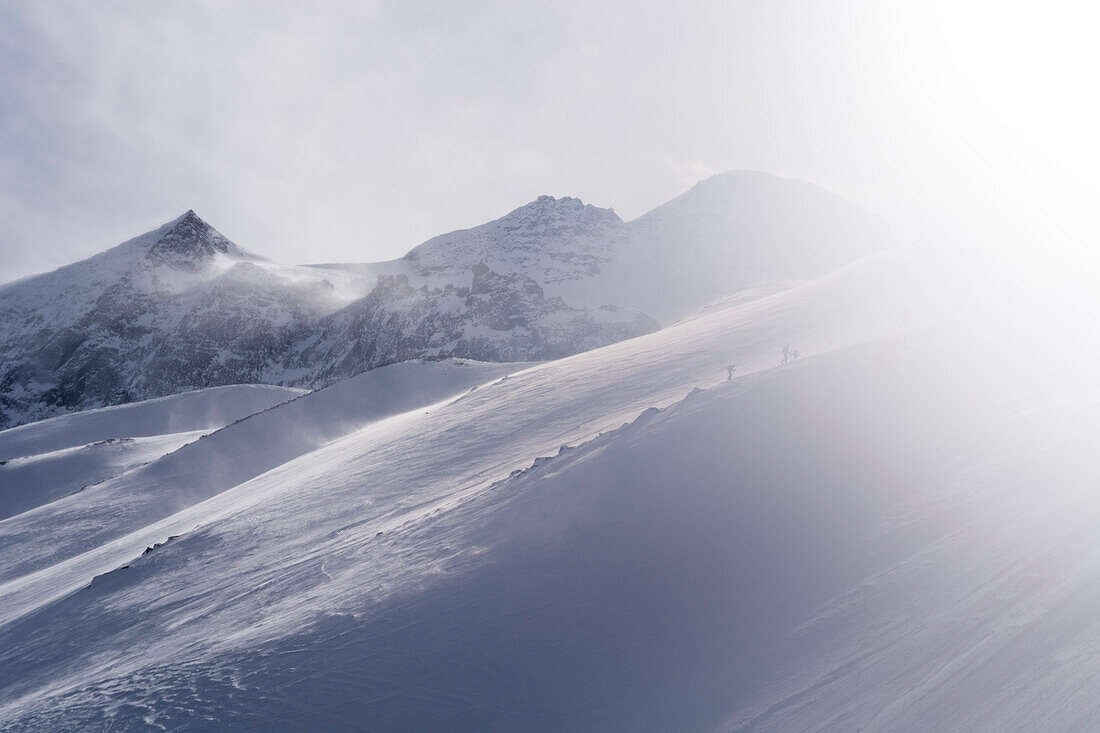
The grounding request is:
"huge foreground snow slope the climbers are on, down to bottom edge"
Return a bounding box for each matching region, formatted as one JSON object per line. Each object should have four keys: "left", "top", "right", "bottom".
{"left": 0, "top": 242, "right": 1100, "bottom": 731}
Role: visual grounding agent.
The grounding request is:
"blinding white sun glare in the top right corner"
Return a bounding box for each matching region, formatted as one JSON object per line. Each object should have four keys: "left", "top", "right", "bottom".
{"left": 875, "top": 1, "right": 1100, "bottom": 246}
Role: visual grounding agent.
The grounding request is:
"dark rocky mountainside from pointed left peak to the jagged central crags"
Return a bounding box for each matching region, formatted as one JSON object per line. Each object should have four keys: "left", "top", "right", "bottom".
{"left": 0, "top": 211, "right": 658, "bottom": 428}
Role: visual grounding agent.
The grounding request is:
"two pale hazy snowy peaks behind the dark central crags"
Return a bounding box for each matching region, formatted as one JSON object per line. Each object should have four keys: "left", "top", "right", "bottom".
{"left": 395, "top": 171, "right": 893, "bottom": 326}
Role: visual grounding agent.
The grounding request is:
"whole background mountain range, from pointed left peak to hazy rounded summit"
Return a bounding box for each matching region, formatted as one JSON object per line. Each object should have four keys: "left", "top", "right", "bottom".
{"left": 0, "top": 172, "right": 892, "bottom": 427}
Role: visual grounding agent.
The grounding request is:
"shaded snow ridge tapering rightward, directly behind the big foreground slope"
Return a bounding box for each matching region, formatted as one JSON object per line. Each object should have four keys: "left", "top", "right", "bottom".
{"left": 0, "top": 360, "right": 527, "bottom": 582}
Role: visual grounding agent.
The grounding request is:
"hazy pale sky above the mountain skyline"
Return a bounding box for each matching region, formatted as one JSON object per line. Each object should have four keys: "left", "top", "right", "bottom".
{"left": 0, "top": 0, "right": 1100, "bottom": 281}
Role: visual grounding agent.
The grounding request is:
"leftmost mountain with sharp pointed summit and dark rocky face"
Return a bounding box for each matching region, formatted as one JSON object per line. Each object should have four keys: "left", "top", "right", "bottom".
{"left": 0, "top": 211, "right": 340, "bottom": 427}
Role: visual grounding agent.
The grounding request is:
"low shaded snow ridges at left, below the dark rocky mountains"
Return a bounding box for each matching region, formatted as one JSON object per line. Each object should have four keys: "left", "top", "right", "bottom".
{"left": 0, "top": 359, "right": 527, "bottom": 582}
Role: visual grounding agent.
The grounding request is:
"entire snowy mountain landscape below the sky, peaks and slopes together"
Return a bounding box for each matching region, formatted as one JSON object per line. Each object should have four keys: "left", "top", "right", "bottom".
{"left": 0, "top": 162, "right": 1100, "bottom": 731}
